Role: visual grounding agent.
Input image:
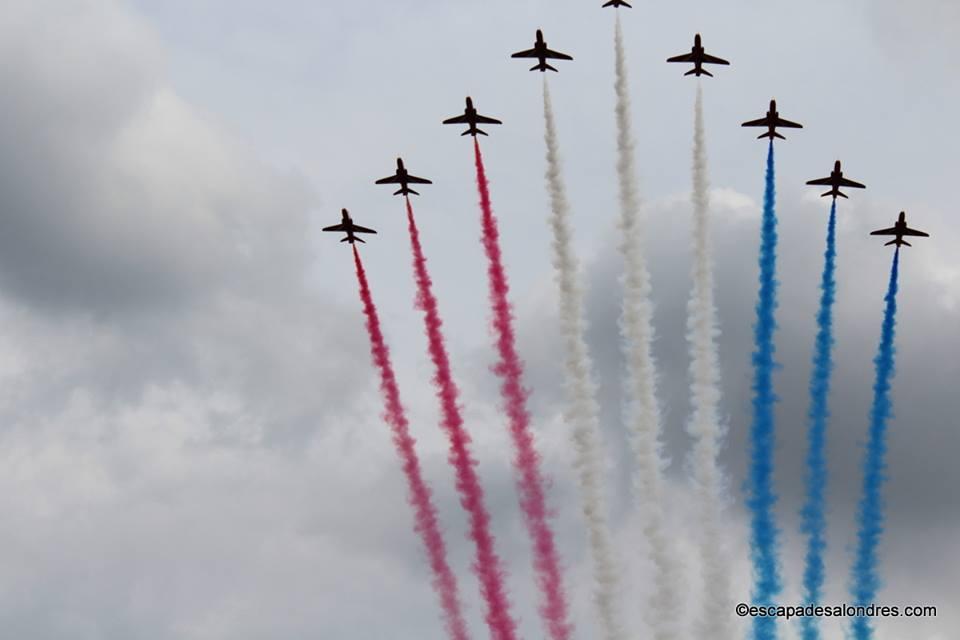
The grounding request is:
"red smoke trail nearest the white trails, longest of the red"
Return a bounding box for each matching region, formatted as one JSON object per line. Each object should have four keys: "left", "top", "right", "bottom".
{"left": 473, "top": 138, "right": 572, "bottom": 640}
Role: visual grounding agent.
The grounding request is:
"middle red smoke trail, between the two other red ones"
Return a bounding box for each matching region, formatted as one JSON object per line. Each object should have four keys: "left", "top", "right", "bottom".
{"left": 406, "top": 197, "right": 516, "bottom": 640}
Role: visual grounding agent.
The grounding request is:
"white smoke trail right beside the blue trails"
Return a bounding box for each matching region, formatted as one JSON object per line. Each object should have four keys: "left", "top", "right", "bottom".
{"left": 687, "top": 84, "right": 733, "bottom": 640}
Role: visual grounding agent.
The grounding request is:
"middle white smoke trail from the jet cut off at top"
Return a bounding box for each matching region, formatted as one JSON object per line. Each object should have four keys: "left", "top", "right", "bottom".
{"left": 614, "top": 16, "right": 681, "bottom": 640}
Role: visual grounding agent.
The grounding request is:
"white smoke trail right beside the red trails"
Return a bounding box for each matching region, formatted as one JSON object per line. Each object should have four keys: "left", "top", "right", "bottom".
{"left": 543, "top": 77, "right": 626, "bottom": 640}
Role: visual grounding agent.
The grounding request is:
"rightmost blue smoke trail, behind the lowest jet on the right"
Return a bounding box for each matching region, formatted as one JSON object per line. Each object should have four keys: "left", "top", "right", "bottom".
{"left": 850, "top": 247, "right": 900, "bottom": 640}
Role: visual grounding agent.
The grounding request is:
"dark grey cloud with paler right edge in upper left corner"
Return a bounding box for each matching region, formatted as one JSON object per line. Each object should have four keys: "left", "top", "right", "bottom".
{"left": 0, "top": 3, "right": 312, "bottom": 314}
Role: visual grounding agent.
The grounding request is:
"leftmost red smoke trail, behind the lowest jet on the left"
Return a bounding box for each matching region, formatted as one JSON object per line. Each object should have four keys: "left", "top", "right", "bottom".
{"left": 353, "top": 245, "right": 469, "bottom": 640}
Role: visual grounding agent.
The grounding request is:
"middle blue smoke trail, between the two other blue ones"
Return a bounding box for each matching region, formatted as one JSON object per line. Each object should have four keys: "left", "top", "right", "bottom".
{"left": 800, "top": 198, "right": 837, "bottom": 640}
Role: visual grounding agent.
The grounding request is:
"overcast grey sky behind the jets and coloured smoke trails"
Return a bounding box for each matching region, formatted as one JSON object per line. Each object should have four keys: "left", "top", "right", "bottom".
{"left": 0, "top": 0, "right": 960, "bottom": 640}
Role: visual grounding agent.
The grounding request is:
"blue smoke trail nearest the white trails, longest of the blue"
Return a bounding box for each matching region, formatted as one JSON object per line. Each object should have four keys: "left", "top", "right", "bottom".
{"left": 747, "top": 140, "right": 780, "bottom": 640}
